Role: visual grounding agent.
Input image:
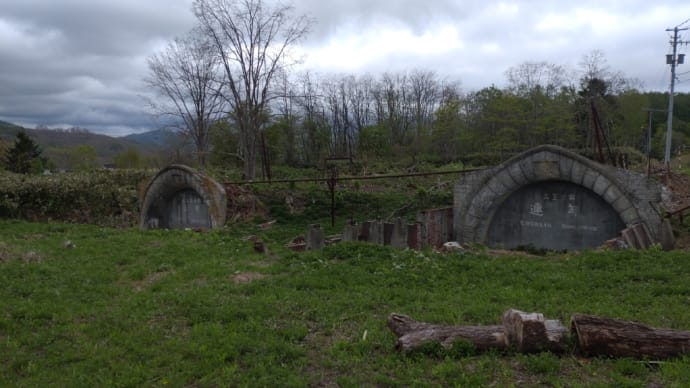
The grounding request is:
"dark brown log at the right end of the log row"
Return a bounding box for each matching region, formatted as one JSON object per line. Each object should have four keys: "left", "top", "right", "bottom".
{"left": 570, "top": 314, "right": 690, "bottom": 359}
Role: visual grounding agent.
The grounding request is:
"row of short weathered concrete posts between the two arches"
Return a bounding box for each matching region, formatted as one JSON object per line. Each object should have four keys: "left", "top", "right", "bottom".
{"left": 306, "top": 208, "right": 453, "bottom": 250}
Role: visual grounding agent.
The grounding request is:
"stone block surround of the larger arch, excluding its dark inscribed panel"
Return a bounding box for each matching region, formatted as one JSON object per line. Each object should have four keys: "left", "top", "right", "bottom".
{"left": 453, "top": 145, "right": 664, "bottom": 248}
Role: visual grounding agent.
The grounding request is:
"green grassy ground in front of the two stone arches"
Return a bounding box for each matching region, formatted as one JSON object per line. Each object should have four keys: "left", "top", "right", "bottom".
{"left": 0, "top": 220, "right": 690, "bottom": 387}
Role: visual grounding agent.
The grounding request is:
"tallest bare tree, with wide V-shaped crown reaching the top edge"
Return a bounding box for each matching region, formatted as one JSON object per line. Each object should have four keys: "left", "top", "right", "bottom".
{"left": 194, "top": 0, "right": 311, "bottom": 179}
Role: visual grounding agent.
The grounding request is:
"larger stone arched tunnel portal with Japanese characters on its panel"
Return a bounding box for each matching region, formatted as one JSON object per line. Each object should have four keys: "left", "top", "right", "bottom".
{"left": 453, "top": 145, "right": 668, "bottom": 250}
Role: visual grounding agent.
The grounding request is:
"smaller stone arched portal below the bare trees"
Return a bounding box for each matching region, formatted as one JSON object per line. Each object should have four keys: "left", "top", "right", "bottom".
{"left": 140, "top": 165, "right": 227, "bottom": 229}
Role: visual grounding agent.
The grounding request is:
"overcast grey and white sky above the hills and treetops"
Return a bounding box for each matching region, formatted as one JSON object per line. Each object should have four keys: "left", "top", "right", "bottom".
{"left": 0, "top": 0, "right": 690, "bottom": 136}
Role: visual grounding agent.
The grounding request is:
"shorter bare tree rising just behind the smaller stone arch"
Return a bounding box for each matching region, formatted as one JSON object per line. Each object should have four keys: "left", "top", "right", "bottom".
{"left": 146, "top": 31, "right": 224, "bottom": 166}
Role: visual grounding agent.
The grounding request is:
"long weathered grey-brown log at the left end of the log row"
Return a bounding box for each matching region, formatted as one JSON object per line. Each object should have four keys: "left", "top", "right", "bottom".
{"left": 388, "top": 314, "right": 506, "bottom": 351}
